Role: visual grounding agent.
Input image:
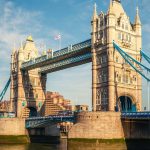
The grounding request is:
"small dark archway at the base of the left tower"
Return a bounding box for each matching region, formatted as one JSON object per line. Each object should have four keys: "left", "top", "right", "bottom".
{"left": 23, "top": 107, "right": 37, "bottom": 118}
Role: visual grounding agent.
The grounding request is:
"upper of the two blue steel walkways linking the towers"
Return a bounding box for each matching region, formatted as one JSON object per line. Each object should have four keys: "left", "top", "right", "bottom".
{"left": 21, "top": 39, "right": 91, "bottom": 70}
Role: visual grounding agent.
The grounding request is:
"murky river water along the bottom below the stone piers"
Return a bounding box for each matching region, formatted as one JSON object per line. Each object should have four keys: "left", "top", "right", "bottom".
{"left": 0, "top": 140, "right": 150, "bottom": 150}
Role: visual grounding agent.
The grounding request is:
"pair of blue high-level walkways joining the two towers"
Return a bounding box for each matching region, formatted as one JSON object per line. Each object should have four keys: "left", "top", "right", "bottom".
{"left": 21, "top": 39, "right": 92, "bottom": 73}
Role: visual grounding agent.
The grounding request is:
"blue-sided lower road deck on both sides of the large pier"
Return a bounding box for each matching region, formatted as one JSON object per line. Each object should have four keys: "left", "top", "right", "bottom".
{"left": 26, "top": 112, "right": 150, "bottom": 128}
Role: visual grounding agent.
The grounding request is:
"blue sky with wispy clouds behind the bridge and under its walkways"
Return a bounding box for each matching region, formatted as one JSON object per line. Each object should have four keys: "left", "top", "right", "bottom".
{"left": 0, "top": 0, "right": 150, "bottom": 109}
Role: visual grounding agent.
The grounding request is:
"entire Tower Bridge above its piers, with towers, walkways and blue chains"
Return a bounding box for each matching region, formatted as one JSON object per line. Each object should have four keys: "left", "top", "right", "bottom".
{"left": 0, "top": 0, "right": 150, "bottom": 141}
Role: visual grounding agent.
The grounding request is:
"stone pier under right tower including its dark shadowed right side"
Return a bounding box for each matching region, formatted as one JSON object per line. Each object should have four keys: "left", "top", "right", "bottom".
{"left": 68, "top": 112, "right": 150, "bottom": 139}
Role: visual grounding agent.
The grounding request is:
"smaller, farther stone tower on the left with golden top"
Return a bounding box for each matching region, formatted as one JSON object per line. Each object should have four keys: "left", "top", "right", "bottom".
{"left": 10, "top": 36, "right": 46, "bottom": 117}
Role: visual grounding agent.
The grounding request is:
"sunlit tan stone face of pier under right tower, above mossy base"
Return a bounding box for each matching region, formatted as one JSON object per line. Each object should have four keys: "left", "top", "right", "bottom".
{"left": 68, "top": 112, "right": 124, "bottom": 139}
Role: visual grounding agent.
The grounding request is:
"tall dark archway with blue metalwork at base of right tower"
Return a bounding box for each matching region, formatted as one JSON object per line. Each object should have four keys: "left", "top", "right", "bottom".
{"left": 118, "top": 96, "right": 136, "bottom": 112}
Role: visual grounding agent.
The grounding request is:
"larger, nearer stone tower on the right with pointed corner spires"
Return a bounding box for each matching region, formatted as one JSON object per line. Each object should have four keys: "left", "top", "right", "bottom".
{"left": 91, "top": 0, "right": 142, "bottom": 111}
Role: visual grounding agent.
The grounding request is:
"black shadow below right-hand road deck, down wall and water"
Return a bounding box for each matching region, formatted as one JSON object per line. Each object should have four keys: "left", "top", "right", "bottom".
{"left": 122, "top": 119, "right": 150, "bottom": 150}
